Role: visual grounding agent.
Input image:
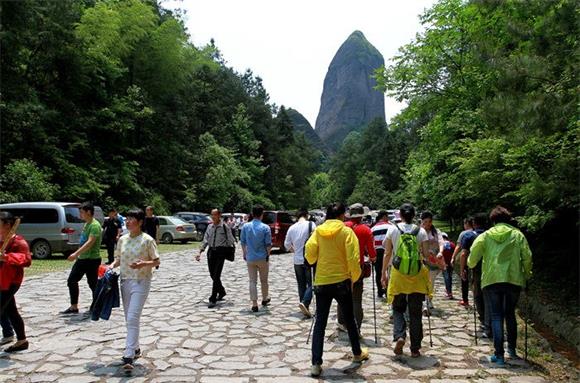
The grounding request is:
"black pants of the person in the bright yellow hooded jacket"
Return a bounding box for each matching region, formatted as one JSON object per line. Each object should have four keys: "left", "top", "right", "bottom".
{"left": 312, "top": 279, "right": 361, "bottom": 364}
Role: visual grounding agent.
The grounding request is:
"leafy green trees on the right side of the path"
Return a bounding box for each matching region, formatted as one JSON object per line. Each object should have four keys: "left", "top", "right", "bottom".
{"left": 376, "top": 0, "right": 580, "bottom": 231}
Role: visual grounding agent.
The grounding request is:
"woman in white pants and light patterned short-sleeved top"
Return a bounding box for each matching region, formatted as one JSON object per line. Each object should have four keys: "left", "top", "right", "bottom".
{"left": 109, "top": 209, "right": 159, "bottom": 369}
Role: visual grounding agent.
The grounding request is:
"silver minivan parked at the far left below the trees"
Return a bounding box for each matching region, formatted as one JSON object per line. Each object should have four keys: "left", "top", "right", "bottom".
{"left": 0, "top": 202, "right": 104, "bottom": 259}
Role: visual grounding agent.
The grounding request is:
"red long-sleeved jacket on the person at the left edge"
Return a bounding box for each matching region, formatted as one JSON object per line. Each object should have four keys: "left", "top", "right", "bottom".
{"left": 0, "top": 235, "right": 32, "bottom": 291}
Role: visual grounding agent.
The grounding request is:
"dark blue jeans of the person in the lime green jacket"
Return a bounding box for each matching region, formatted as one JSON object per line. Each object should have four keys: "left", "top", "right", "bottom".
{"left": 483, "top": 283, "right": 521, "bottom": 358}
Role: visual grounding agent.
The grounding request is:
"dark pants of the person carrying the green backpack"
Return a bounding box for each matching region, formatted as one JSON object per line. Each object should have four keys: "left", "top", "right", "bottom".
{"left": 393, "top": 293, "right": 425, "bottom": 352}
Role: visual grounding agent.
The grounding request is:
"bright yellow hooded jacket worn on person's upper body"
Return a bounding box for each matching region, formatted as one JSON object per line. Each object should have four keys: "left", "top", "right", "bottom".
{"left": 305, "top": 219, "right": 361, "bottom": 286}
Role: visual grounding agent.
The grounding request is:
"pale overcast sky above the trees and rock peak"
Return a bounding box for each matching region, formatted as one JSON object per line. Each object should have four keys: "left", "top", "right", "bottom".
{"left": 163, "top": 0, "right": 435, "bottom": 127}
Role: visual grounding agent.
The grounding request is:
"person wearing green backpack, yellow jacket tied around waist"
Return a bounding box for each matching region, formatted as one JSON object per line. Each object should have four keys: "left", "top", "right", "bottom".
{"left": 381, "top": 203, "right": 433, "bottom": 358}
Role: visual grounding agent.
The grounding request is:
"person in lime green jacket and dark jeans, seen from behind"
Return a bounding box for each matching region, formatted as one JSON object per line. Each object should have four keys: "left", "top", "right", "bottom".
{"left": 467, "top": 205, "right": 532, "bottom": 365}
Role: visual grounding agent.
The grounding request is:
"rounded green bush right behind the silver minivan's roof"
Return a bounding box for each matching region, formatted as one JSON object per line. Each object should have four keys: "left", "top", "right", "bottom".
{"left": 0, "top": 159, "right": 59, "bottom": 203}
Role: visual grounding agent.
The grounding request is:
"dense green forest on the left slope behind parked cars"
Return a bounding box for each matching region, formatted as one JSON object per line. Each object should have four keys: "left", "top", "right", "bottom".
{"left": 0, "top": 0, "right": 316, "bottom": 213}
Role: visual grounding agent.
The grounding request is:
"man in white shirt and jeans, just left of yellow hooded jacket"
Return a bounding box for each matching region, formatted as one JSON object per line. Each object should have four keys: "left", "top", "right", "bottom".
{"left": 284, "top": 209, "right": 316, "bottom": 318}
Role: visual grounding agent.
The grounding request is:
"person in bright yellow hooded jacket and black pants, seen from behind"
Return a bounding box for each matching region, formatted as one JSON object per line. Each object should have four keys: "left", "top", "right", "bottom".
{"left": 306, "top": 203, "right": 369, "bottom": 376}
